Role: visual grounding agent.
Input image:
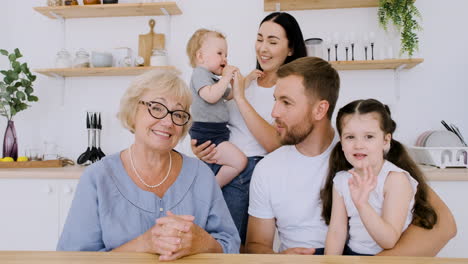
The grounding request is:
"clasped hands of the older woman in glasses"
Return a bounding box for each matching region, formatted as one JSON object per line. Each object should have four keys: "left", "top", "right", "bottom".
{"left": 147, "top": 211, "right": 199, "bottom": 261}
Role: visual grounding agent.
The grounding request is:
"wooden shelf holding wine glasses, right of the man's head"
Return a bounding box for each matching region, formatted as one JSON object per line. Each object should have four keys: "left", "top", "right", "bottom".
{"left": 330, "top": 59, "right": 424, "bottom": 71}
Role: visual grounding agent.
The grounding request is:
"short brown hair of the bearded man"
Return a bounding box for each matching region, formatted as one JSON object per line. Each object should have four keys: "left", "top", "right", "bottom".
{"left": 277, "top": 57, "right": 340, "bottom": 120}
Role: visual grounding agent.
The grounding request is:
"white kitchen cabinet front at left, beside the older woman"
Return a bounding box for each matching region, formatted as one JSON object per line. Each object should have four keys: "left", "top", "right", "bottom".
{"left": 0, "top": 179, "right": 78, "bottom": 250}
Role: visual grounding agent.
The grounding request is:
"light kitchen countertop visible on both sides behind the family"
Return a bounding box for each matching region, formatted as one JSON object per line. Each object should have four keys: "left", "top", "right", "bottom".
{"left": 0, "top": 165, "right": 468, "bottom": 181}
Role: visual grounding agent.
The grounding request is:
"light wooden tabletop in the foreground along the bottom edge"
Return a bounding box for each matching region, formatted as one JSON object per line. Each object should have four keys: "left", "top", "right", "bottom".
{"left": 0, "top": 251, "right": 468, "bottom": 264}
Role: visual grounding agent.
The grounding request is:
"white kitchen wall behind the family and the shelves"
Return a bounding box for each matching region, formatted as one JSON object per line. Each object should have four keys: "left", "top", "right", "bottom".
{"left": 0, "top": 0, "right": 468, "bottom": 256}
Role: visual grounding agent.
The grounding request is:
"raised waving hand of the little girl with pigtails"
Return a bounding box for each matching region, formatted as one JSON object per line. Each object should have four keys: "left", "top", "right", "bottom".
{"left": 348, "top": 166, "right": 377, "bottom": 208}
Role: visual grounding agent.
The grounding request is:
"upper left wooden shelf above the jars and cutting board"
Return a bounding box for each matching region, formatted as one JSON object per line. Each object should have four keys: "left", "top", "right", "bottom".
{"left": 34, "top": 2, "right": 182, "bottom": 19}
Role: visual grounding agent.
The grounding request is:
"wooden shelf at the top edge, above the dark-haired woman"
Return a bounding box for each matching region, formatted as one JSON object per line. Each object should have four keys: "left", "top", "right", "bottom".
{"left": 264, "top": 0, "right": 379, "bottom": 11}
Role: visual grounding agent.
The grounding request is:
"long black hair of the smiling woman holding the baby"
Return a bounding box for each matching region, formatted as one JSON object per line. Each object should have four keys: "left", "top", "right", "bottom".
{"left": 257, "top": 12, "right": 307, "bottom": 70}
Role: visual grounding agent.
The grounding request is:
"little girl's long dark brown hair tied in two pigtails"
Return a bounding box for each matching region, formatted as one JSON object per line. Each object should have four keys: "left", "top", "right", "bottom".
{"left": 320, "top": 99, "right": 437, "bottom": 229}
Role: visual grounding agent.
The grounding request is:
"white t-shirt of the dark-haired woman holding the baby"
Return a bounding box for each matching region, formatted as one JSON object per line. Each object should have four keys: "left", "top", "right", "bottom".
{"left": 227, "top": 80, "right": 275, "bottom": 157}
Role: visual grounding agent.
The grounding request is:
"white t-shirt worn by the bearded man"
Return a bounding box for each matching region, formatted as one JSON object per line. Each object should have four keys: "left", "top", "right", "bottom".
{"left": 249, "top": 132, "right": 339, "bottom": 251}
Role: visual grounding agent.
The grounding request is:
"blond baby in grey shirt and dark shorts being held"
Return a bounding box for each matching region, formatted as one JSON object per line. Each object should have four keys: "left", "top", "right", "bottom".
{"left": 187, "top": 29, "right": 247, "bottom": 187}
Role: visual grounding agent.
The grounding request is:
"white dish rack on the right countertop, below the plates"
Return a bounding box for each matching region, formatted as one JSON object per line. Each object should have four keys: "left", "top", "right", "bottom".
{"left": 408, "top": 147, "right": 468, "bottom": 169}
